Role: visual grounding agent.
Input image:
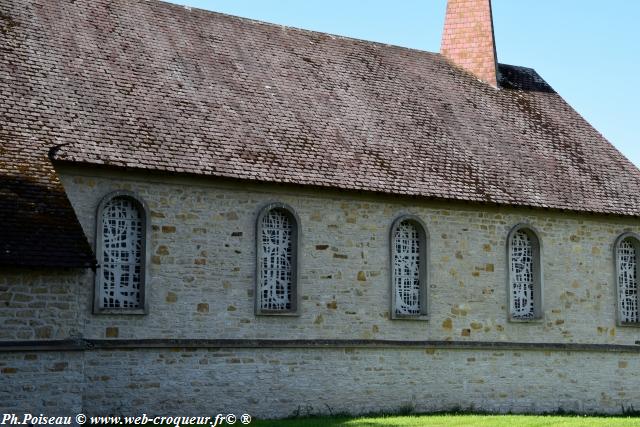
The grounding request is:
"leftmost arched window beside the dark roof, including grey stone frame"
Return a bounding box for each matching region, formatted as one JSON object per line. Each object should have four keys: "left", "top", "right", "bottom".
{"left": 94, "top": 191, "right": 148, "bottom": 314}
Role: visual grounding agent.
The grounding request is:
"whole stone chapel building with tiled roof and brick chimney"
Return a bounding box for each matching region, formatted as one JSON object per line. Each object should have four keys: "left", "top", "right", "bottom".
{"left": 0, "top": 0, "right": 640, "bottom": 417}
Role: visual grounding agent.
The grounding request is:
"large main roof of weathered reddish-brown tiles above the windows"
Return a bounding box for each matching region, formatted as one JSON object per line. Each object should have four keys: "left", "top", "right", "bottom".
{"left": 0, "top": 0, "right": 640, "bottom": 264}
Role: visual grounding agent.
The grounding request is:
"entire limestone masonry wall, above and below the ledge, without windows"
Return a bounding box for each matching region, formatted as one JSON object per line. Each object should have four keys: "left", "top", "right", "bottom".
{"left": 0, "top": 165, "right": 640, "bottom": 417}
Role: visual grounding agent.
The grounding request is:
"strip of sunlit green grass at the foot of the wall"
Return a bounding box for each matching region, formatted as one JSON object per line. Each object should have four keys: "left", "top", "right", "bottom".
{"left": 251, "top": 415, "right": 640, "bottom": 427}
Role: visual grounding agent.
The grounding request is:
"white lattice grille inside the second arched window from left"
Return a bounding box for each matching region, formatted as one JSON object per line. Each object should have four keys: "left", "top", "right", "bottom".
{"left": 258, "top": 208, "right": 295, "bottom": 312}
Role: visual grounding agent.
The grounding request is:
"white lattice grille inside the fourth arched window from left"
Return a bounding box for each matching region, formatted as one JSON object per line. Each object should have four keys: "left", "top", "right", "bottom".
{"left": 510, "top": 230, "right": 537, "bottom": 320}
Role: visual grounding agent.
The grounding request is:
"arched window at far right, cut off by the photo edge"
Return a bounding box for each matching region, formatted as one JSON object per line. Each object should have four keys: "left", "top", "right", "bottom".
{"left": 615, "top": 233, "right": 640, "bottom": 325}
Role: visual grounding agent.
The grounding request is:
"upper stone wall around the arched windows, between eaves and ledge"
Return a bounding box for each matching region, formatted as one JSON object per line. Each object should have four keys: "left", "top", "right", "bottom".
{"left": 53, "top": 169, "right": 640, "bottom": 344}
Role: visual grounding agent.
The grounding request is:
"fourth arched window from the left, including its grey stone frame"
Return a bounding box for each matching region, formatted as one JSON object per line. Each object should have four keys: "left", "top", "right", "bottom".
{"left": 507, "top": 225, "right": 543, "bottom": 321}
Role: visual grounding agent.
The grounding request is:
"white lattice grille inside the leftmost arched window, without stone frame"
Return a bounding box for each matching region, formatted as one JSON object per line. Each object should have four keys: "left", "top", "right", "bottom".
{"left": 99, "top": 197, "right": 144, "bottom": 309}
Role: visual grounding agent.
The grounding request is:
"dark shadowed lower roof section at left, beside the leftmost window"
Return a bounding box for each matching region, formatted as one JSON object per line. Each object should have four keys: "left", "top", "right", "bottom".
{"left": 0, "top": 140, "right": 95, "bottom": 267}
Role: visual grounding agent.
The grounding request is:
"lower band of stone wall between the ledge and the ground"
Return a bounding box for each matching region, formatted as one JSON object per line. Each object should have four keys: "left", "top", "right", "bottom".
{"left": 0, "top": 349, "right": 640, "bottom": 418}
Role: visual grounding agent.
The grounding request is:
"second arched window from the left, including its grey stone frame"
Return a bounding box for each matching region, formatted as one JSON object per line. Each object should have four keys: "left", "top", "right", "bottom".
{"left": 256, "top": 203, "right": 300, "bottom": 314}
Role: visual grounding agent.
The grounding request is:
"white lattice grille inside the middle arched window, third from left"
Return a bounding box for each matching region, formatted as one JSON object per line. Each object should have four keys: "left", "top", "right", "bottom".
{"left": 393, "top": 221, "right": 422, "bottom": 316}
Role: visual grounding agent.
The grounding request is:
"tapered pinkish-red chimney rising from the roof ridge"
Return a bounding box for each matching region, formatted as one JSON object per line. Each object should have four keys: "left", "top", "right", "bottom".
{"left": 440, "top": 0, "right": 498, "bottom": 87}
